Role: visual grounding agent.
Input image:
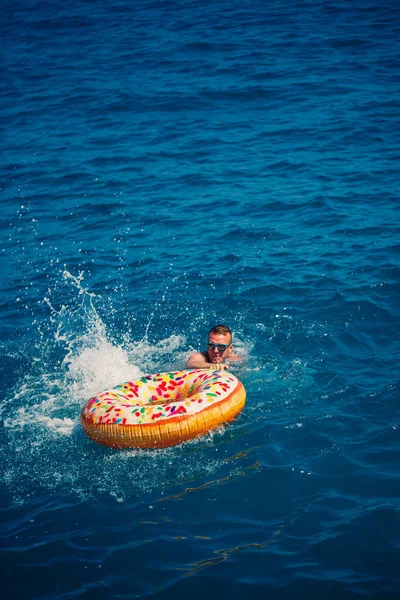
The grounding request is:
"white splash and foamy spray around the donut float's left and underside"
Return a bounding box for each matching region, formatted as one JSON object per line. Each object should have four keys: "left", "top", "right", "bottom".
{"left": 0, "top": 270, "right": 234, "bottom": 502}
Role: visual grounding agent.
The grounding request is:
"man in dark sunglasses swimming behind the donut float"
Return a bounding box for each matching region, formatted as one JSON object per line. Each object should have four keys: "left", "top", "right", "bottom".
{"left": 186, "top": 325, "right": 240, "bottom": 370}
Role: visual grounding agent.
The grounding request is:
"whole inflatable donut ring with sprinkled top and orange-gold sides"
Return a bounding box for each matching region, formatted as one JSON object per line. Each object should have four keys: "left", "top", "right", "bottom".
{"left": 81, "top": 369, "right": 246, "bottom": 448}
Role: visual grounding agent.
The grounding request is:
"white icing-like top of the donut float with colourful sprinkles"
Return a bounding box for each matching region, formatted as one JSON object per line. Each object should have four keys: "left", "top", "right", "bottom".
{"left": 82, "top": 369, "right": 238, "bottom": 426}
